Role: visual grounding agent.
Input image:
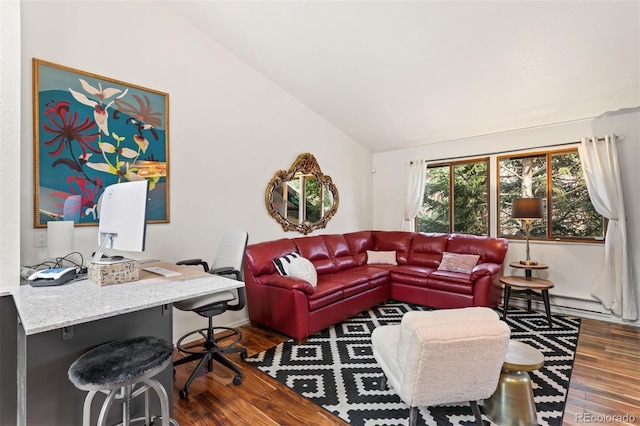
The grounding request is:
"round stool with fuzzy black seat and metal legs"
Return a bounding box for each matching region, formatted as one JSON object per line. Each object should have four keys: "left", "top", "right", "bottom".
{"left": 68, "top": 336, "right": 177, "bottom": 426}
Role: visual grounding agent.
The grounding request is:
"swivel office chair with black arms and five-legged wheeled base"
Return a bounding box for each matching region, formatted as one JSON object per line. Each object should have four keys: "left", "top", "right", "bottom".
{"left": 173, "top": 231, "right": 249, "bottom": 398}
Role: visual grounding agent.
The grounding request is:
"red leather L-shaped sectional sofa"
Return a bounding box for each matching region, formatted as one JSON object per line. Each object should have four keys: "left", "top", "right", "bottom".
{"left": 244, "top": 231, "right": 508, "bottom": 342}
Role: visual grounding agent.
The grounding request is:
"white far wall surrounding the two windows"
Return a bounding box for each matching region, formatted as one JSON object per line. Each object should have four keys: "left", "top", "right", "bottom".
{"left": 373, "top": 108, "right": 640, "bottom": 320}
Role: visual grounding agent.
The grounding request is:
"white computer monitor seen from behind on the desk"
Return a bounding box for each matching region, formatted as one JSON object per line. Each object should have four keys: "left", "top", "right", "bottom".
{"left": 93, "top": 180, "right": 149, "bottom": 263}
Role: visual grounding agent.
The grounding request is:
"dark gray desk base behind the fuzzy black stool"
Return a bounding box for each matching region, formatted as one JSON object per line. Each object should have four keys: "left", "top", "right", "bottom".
{"left": 16, "top": 305, "right": 173, "bottom": 426}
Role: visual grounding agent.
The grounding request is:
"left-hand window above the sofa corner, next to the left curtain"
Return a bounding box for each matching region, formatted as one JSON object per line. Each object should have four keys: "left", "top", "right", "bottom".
{"left": 416, "top": 158, "right": 489, "bottom": 235}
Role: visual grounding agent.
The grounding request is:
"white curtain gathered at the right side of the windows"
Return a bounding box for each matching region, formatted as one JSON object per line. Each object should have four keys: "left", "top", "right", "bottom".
{"left": 578, "top": 135, "right": 638, "bottom": 321}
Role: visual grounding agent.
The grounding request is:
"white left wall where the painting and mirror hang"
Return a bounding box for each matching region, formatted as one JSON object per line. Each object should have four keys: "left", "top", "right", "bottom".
{"left": 20, "top": 0, "right": 372, "bottom": 337}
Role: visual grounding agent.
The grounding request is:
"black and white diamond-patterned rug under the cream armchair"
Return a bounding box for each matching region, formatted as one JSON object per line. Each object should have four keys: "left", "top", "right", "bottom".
{"left": 246, "top": 301, "right": 580, "bottom": 426}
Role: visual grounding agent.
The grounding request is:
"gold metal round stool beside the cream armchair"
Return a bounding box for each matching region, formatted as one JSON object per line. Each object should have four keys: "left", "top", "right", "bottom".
{"left": 483, "top": 340, "right": 544, "bottom": 426}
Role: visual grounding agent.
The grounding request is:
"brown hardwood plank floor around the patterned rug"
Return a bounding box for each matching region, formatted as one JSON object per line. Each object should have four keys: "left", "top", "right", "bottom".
{"left": 173, "top": 319, "right": 640, "bottom": 426}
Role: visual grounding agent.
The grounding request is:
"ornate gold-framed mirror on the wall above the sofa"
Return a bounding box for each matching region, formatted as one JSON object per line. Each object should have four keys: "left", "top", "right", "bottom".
{"left": 265, "top": 153, "right": 340, "bottom": 235}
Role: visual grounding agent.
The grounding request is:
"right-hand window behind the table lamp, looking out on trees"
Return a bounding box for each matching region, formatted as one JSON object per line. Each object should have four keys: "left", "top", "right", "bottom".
{"left": 498, "top": 149, "right": 605, "bottom": 241}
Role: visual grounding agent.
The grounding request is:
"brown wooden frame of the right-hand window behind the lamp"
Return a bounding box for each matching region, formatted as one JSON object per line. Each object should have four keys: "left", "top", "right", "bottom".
{"left": 496, "top": 147, "right": 608, "bottom": 244}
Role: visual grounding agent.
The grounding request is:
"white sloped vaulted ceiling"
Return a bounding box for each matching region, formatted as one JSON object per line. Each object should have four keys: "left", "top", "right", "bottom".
{"left": 170, "top": 0, "right": 640, "bottom": 152}
